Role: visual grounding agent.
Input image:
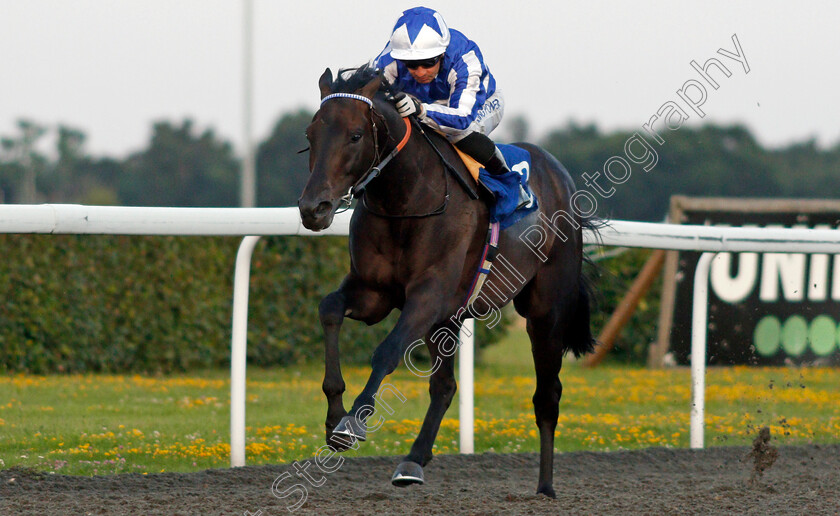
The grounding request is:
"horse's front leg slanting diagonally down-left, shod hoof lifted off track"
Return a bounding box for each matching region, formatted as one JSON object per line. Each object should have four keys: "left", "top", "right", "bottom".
{"left": 335, "top": 281, "right": 442, "bottom": 443}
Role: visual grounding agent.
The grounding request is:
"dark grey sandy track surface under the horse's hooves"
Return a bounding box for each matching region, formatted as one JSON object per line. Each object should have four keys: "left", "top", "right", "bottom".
{"left": 0, "top": 444, "right": 840, "bottom": 516}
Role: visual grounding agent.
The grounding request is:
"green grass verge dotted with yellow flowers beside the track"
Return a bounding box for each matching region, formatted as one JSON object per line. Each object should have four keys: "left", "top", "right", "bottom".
{"left": 0, "top": 331, "right": 840, "bottom": 475}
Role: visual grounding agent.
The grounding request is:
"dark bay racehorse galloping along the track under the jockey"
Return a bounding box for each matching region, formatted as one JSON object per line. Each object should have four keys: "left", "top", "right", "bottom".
{"left": 298, "top": 67, "right": 593, "bottom": 497}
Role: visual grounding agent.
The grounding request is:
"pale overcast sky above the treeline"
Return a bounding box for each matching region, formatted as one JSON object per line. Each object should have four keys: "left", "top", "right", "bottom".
{"left": 0, "top": 0, "right": 840, "bottom": 156}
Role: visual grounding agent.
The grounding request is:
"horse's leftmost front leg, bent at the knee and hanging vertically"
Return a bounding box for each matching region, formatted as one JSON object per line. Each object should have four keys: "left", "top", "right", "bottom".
{"left": 318, "top": 281, "right": 392, "bottom": 451}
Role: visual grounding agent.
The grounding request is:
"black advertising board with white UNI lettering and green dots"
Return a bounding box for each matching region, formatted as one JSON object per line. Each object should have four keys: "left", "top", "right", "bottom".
{"left": 660, "top": 197, "right": 840, "bottom": 365}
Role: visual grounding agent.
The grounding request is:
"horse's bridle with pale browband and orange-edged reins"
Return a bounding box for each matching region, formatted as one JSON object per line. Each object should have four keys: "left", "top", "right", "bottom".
{"left": 321, "top": 93, "right": 449, "bottom": 218}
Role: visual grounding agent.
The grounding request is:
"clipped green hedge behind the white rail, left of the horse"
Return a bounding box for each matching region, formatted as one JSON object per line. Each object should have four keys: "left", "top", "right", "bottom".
{"left": 0, "top": 235, "right": 504, "bottom": 373}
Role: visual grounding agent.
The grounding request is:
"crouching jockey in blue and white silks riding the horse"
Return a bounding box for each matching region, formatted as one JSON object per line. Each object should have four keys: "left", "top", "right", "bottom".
{"left": 372, "top": 7, "right": 530, "bottom": 203}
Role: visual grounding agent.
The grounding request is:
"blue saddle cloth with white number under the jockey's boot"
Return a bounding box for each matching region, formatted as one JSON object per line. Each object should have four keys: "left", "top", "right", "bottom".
{"left": 478, "top": 144, "right": 538, "bottom": 229}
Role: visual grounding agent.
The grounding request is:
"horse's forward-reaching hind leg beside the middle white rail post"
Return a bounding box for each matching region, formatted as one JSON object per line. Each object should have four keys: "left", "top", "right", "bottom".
{"left": 391, "top": 323, "right": 460, "bottom": 486}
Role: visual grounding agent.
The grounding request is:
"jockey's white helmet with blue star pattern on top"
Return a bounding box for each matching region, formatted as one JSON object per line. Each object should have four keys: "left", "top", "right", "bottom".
{"left": 391, "top": 7, "right": 449, "bottom": 61}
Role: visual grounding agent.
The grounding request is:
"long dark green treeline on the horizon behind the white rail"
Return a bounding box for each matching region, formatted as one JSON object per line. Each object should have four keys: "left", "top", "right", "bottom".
{"left": 0, "top": 109, "right": 840, "bottom": 221}
